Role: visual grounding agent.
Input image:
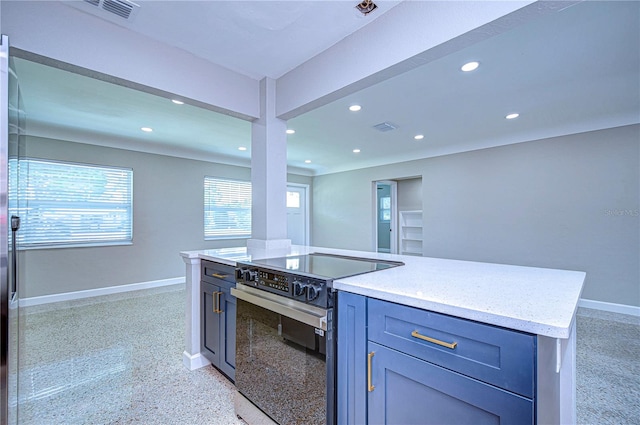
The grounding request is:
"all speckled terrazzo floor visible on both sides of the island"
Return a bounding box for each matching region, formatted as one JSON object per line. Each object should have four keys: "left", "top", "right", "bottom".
{"left": 12, "top": 285, "right": 640, "bottom": 425}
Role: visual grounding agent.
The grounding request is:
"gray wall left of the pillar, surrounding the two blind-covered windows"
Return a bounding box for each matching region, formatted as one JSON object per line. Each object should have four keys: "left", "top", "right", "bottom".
{"left": 20, "top": 137, "right": 311, "bottom": 297}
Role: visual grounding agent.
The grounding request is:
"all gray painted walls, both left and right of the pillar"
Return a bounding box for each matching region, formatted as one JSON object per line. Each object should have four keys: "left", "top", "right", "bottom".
{"left": 21, "top": 125, "right": 640, "bottom": 306}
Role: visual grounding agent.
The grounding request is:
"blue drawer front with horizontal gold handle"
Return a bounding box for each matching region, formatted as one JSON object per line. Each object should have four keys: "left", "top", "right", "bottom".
{"left": 368, "top": 299, "right": 536, "bottom": 398}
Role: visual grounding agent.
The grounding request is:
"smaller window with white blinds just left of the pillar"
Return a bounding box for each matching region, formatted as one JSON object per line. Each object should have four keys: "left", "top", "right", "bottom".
{"left": 204, "top": 177, "right": 251, "bottom": 239}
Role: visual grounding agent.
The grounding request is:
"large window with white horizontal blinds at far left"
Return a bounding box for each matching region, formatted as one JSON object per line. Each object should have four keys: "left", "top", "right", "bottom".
{"left": 9, "top": 159, "right": 133, "bottom": 248}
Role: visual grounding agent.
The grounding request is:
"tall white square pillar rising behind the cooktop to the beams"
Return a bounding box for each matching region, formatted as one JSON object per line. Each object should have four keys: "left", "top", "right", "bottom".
{"left": 247, "top": 78, "right": 291, "bottom": 249}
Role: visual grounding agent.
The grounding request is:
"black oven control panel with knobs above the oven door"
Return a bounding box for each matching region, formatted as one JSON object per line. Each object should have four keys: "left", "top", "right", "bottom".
{"left": 236, "top": 266, "right": 332, "bottom": 308}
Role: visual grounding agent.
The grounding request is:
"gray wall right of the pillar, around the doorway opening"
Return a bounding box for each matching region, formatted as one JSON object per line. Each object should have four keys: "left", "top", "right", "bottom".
{"left": 312, "top": 125, "right": 640, "bottom": 306}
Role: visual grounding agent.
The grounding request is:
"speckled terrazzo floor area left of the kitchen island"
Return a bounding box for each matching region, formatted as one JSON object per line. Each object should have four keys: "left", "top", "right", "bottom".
{"left": 18, "top": 285, "right": 244, "bottom": 425}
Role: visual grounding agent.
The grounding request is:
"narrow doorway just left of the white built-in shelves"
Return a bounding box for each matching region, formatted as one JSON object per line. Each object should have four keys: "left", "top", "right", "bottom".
{"left": 373, "top": 180, "right": 398, "bottom": 254}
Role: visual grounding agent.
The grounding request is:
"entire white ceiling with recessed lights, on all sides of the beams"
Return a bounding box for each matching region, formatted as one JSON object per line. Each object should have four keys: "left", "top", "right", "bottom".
{"left": 10, "top": 1, "right": 640, "bottom": 174}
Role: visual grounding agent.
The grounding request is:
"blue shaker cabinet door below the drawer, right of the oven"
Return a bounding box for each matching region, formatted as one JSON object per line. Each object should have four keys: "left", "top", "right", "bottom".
{"left": 367, "top": 342, "right": 534, "bottom": 425}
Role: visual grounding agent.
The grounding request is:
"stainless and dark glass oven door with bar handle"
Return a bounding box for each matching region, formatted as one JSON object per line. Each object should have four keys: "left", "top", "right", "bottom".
{"left": 231, "top": 284, "right": 335, "bottom": 425}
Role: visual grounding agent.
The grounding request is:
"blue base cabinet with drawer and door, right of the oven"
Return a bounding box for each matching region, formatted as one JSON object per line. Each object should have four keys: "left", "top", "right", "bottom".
{"left": 337, "top": 292, "right": 536, "bottom": 425}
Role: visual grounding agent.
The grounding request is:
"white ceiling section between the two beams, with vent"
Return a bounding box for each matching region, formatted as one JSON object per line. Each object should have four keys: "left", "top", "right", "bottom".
{"left": 114, "top": 0, "right": 400, "bottom": 79}
